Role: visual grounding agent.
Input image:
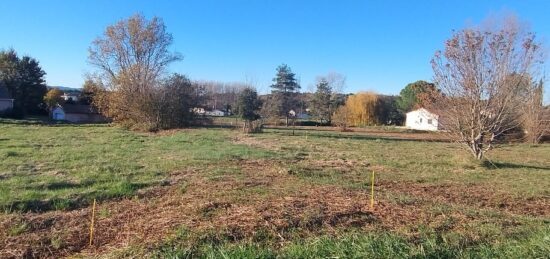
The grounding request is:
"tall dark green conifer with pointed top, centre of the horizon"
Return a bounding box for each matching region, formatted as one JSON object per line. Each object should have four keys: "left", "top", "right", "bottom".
{"left": 271, "top": 64, "right": 300, "bottom": 126}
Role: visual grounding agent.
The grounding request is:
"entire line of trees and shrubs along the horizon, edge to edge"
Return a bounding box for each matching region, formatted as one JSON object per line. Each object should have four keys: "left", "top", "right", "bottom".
{"left": 0, "top": 12, "right": 550, "bottom": 159}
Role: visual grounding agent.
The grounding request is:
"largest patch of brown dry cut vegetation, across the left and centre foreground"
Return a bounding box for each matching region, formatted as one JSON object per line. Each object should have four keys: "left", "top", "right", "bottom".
{"left": 0, "top": 161, "right": 423, "bottom": 258}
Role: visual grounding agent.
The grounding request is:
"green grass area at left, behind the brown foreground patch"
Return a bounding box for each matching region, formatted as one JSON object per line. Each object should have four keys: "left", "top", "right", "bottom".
{"left": 0, "top": 120, "right": 272, "bottom": 211}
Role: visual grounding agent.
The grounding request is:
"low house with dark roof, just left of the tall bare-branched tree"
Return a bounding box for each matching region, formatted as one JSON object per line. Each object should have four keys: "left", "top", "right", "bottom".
{"left": 51, "top": 104, "right": 108, "bottom": 123}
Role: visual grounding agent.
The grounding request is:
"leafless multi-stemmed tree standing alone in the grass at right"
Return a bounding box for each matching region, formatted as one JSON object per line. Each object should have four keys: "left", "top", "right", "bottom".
{"left": 429, "top": 17, "right": 543, "bottom": 159}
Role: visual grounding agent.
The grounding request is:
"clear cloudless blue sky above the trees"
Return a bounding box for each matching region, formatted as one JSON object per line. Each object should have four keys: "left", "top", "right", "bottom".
{"left": 0, "top": 0, "right": 550, "bottom": 94}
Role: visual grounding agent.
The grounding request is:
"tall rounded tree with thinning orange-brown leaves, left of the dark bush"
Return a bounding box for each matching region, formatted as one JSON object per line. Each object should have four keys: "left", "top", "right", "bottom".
{"left": 88, "top": 14, "right": 181, "bottom": 129}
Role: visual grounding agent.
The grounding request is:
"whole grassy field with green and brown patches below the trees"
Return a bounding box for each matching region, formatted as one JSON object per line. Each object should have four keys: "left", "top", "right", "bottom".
{"left": 0, "top": 120, "right": 550, "bottom": 258}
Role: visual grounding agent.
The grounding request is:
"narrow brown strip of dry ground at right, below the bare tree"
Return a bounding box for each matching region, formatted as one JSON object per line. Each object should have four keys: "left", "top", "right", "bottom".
{"left": 379, "top": 182, "right": 550, "bottom": 217}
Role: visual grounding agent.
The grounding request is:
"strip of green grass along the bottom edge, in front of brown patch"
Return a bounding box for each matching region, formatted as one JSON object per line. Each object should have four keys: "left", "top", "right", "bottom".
{"left": 148, "top": 226, "right": 550, "bottom": 258}
